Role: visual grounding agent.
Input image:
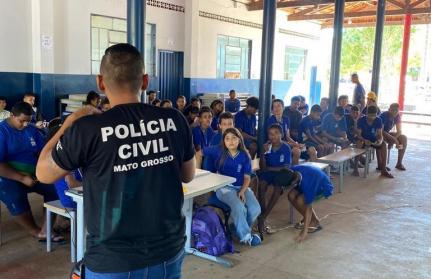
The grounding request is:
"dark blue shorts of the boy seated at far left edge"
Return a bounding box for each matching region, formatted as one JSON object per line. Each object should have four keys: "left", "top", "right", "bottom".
{"left": 0, "top": 177, "right": 58, "bottom": 216}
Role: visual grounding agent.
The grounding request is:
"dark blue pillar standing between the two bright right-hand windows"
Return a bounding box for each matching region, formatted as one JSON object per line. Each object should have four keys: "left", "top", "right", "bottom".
{"left": 258, "top": 0, "right": 277, "bottom": 150}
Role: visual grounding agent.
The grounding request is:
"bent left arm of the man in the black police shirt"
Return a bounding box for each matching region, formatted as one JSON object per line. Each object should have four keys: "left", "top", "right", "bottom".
{"left": 36, "top": 106, "right": 100, "bottom": 184}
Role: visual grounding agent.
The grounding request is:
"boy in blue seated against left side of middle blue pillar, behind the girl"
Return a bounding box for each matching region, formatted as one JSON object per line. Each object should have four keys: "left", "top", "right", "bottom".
{"left": 235, "top": 97, "right": 259, "bottom": 159}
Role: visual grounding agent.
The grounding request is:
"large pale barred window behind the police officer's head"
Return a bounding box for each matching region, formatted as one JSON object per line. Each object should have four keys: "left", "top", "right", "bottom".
{"left": 91, "top": 15, "right": 156, "bottom": 76}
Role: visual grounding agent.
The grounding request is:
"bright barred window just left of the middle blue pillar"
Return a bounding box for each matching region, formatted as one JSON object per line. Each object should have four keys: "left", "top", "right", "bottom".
{"left": 217, "top": 35, "right": 251, "bottom": 79}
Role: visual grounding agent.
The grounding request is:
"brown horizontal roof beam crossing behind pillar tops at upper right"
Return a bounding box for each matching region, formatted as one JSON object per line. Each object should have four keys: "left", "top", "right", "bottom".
{"left": 287, "top": 7, "right": 431, "bottom": 21}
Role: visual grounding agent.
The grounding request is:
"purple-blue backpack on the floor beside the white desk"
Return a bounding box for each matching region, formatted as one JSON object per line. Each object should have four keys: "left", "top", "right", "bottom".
{"left": 192, "top": 206, "right": 234, "bottom": 256}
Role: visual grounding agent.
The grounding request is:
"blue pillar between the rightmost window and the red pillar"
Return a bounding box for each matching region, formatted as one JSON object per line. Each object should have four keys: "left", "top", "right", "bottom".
{"left": 329, "top": 0, "right": 345, "bottom": 110}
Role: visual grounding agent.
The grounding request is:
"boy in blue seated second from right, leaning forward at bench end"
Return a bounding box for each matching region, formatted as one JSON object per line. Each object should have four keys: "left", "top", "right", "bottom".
{"left": 355, "top": 106, "right": 394, "bottom": 178}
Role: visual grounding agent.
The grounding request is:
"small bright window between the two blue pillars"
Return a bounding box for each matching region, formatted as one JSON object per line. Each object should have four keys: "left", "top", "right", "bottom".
{"left": 284, "top": 47, "right": 307, "bottom": 80}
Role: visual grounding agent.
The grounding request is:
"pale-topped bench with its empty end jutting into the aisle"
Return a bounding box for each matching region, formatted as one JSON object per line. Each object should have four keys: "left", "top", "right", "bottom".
{"left": 317, "top": 147, "right": 369, "bottom": 193}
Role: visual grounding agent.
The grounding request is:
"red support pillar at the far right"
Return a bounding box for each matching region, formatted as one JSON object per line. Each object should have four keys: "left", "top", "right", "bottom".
{"left": 398, "top": 14, "right": 412, "bottom": 110}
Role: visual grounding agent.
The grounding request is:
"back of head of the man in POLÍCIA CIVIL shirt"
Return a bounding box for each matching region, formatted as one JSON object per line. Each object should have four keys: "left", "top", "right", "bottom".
{"left": 100, "top": 43, "right": 145, "bottom": 91}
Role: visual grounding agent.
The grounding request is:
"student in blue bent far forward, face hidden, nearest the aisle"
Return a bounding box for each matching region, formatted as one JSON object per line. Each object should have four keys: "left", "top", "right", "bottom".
{"left": 286, "top": 165, "right": 334, "bottom": 242}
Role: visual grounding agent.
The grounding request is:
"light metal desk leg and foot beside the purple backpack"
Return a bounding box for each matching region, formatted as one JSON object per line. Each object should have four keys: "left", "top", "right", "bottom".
{"left": 183, "top": 198, "right": 233, "bottom": 267}
